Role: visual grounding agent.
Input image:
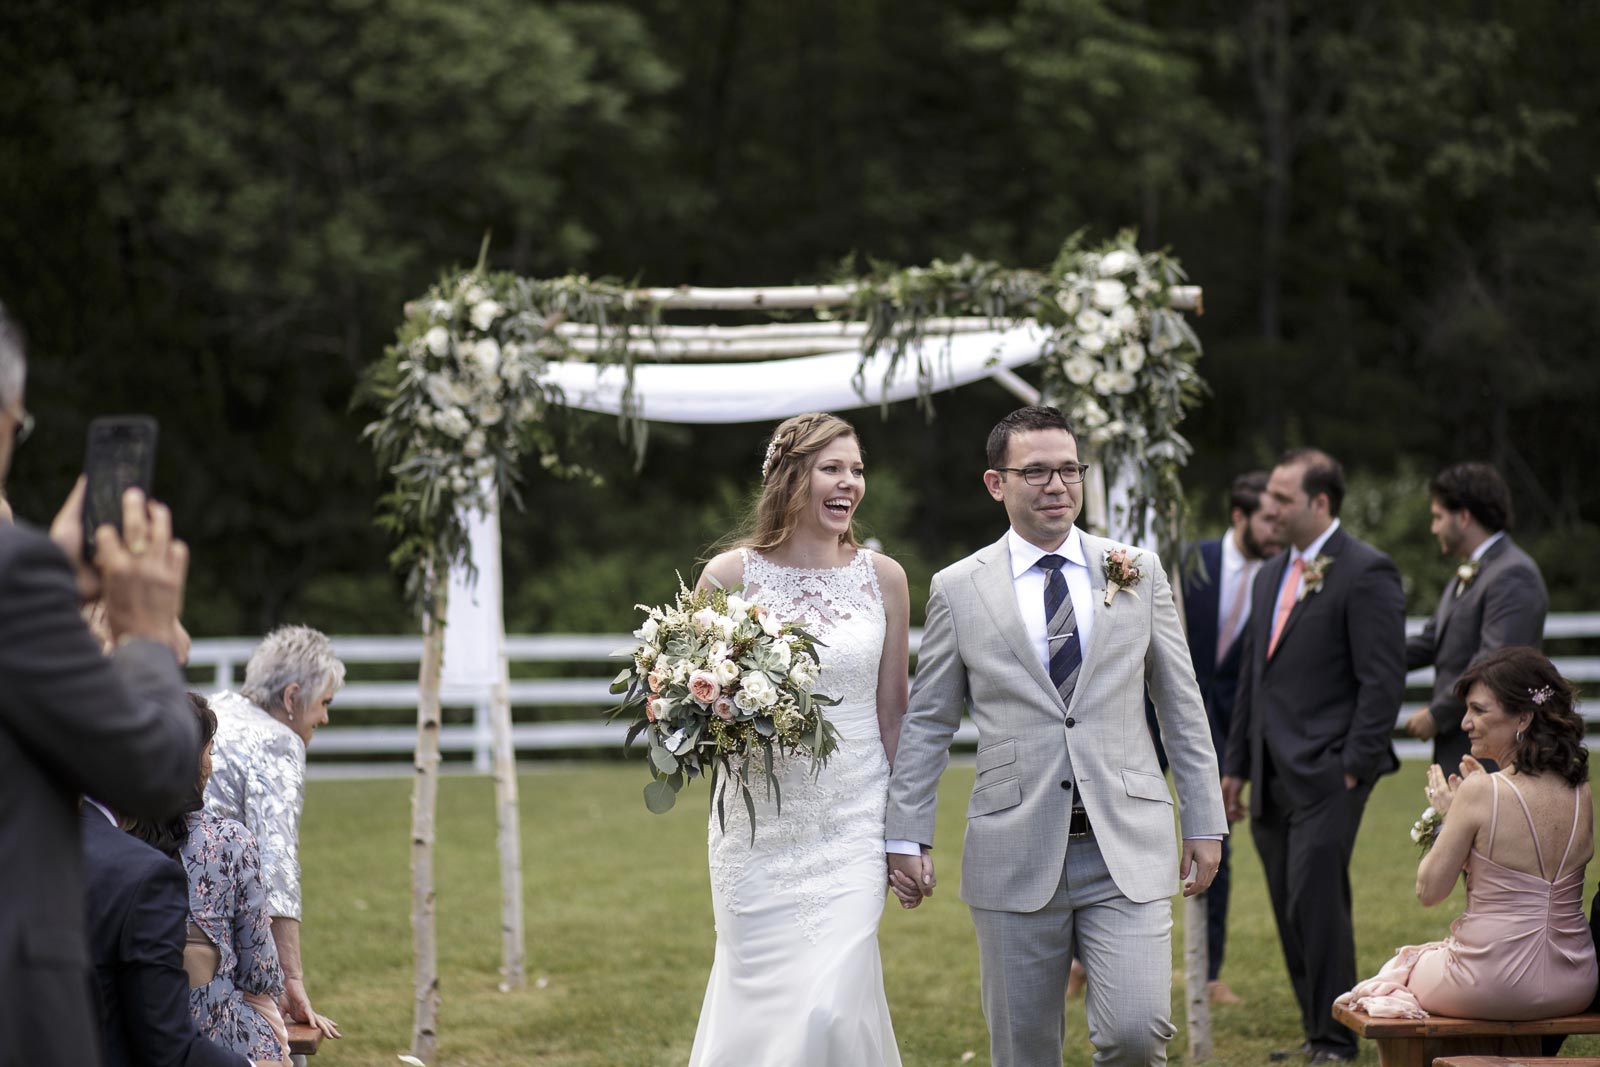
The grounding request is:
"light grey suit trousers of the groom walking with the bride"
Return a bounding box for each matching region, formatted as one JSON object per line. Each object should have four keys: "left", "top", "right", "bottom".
{"left": 971, "top": 835, "right": 1174, "bottom": 1067}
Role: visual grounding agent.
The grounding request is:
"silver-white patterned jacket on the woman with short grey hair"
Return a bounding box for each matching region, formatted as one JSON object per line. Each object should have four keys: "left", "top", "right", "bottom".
{"left": 205, "top": 691, "right": 306, "bottom": 921}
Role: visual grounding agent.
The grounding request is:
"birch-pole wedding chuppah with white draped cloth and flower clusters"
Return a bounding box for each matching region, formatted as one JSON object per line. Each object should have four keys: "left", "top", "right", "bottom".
{"left": 368, "top": 234, "right": 1208, "bottom": 1061}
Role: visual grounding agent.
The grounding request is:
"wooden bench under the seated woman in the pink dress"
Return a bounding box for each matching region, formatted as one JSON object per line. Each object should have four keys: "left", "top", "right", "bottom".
{"left": 1333, "top": 1005, "right": 1600, "bottom": 1067}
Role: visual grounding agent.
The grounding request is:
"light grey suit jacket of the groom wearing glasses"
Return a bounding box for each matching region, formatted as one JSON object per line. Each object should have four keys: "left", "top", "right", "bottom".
{"left": 885, "top": 534, "right": 1227, "bottom": 912}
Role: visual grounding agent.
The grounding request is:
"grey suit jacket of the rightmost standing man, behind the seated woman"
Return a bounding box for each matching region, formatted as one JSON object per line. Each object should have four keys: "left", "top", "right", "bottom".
{"left": 1405, "top": 534, "right": 1550, "bottom": 734}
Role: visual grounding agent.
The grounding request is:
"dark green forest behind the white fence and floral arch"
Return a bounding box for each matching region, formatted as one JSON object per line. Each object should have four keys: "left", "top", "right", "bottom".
{"left": 0, "top": 0, "right": 1600, "bottom": 637}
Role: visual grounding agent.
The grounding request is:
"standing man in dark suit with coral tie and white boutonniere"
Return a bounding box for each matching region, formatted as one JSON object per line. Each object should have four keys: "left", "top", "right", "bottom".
{"left": 1222, "top": 450, "right": 1405, "bottom": 1064}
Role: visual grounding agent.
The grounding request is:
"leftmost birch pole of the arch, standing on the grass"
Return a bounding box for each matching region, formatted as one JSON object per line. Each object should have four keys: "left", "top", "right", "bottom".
{"left": 411, "top": 582, "right": 450, "bottom": 1065}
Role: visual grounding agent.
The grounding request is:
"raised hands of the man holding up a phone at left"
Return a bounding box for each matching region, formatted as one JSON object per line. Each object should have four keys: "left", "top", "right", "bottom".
{"left": 50, "top": 478, "right": 189, "bottom": 651}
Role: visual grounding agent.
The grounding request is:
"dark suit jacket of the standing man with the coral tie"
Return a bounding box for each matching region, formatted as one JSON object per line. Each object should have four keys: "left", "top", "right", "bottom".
{"left": 1224, "top": 526, "right": 1405, "bottom": 816}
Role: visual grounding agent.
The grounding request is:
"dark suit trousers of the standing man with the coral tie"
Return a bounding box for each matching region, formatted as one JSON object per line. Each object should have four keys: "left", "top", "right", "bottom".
{"left": 1250, "top": 757, "right": 1373, "bottom": 1056}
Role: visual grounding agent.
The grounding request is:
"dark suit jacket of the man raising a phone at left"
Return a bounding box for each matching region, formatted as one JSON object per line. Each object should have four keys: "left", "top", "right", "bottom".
{"left": 0, "top": 523, "right": 200, "bottom": 1067}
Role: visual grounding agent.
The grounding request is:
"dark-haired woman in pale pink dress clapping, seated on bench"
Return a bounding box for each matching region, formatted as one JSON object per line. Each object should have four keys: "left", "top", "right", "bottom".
{"left": 1339, "top": 648, "right": 1595, "bottom": 1019}
